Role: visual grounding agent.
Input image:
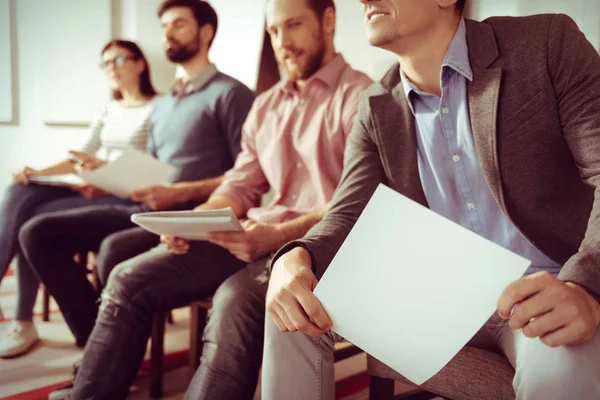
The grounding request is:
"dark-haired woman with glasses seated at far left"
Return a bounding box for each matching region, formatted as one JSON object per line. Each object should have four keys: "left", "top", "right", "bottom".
{"left": 0, "top": 40, "right": 156, "bottom": 358}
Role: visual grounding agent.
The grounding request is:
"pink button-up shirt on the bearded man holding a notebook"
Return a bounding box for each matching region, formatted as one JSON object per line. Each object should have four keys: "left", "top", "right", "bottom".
{"left": 215, "top": 55, "right": 371, "bottom": 223}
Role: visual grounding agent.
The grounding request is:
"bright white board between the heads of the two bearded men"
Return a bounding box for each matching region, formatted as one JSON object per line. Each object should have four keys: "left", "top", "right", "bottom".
{"left": 210, "top": 0, "right": 266, "bottom": 90}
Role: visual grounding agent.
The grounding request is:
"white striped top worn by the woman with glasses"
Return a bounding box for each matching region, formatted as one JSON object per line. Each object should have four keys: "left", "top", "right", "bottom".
{"left": 81, "top": 96, "right": 158, "bottom": 161}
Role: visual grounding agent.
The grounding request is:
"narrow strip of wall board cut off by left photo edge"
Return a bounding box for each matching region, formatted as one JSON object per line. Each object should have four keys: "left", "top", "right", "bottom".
{"left": 0, "top": 0, "right": 13, "bottom": 123}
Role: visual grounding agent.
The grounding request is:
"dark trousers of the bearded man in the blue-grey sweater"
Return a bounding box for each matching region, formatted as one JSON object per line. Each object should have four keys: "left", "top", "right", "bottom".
{"left": 20, "top": 204, "right": 150, "bottom": 347}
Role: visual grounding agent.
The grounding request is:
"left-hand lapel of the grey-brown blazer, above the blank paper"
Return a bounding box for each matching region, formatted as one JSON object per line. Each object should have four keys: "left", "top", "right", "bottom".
{"left": 369, "top": 65, "right": 427, "bottom": 207}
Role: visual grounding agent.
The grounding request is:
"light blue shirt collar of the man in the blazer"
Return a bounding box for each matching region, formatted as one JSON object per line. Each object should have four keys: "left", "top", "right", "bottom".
{"left": 400, "top": 18, "right": 473, "bottom": 113}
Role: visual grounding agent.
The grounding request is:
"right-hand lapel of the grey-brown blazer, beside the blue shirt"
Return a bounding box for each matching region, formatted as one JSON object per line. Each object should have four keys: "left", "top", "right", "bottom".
{"left": 466, "top": 20, "right": 507, "bottom": 213}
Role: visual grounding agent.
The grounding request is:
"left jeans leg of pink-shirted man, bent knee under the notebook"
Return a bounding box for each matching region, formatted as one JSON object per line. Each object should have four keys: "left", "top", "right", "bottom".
{"left": 72, "top": 242, "right": 246, "bottom": 400}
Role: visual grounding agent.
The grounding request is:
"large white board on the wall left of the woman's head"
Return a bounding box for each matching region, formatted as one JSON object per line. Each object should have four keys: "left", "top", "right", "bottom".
{"left": 33, "top": 0, "right": 112, "bottom": 125}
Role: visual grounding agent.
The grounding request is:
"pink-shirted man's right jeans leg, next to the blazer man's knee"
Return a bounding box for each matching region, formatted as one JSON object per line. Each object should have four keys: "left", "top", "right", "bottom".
{"left": 185, "top": 258, "right": 270, "bottom": 400}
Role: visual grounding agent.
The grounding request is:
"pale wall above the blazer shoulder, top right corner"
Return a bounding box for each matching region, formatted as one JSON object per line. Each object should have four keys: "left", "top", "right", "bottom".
{"left": 467, "top": 0, "right": 600, "bottom": 49}
